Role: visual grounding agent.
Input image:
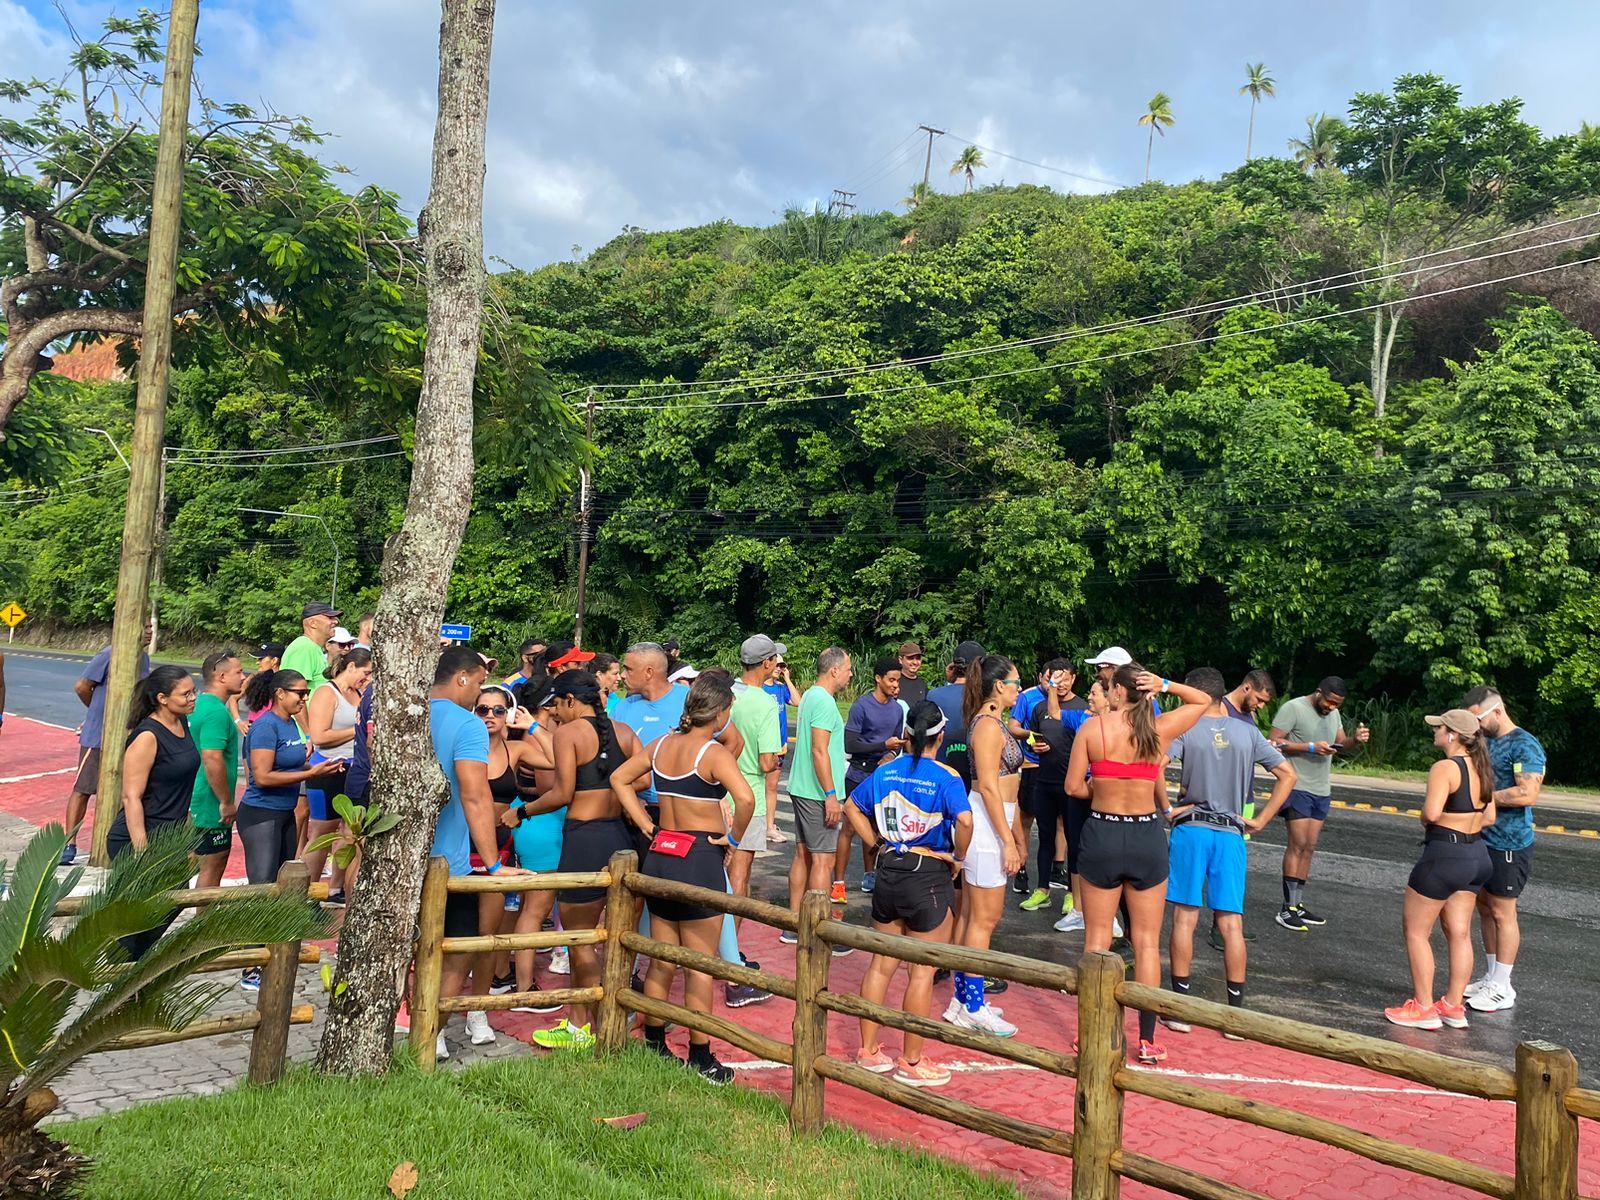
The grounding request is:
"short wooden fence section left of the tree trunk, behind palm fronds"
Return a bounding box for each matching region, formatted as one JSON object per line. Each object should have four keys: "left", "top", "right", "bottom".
{"left": 56, "top": 859, "right": 328, "bottom": 1083}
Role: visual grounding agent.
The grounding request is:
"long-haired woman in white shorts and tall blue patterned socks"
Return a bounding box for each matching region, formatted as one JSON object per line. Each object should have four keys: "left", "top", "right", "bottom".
{"left": 944, "top": 654, "right": 1027, "bottom": 1037}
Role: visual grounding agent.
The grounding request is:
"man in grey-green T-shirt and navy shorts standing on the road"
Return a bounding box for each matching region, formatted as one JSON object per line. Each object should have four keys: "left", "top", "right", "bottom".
{"left": 1267, "top": 675, "right": 1368, "bottom": 933}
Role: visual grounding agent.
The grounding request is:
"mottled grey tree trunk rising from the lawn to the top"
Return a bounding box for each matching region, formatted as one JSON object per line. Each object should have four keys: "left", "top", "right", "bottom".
{"left": 318, "top": 0, "right": 494, "bottom": 1074}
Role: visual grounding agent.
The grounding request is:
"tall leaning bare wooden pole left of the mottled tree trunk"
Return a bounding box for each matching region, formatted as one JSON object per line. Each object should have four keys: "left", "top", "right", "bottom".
{"left": 90, "top": 0, "right": 200, "bottom": 866}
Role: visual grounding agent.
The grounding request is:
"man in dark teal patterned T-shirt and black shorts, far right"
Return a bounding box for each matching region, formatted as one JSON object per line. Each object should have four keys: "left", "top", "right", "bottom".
{"left": 1461, "top": 686, "right": 1544, "bottom": 1013}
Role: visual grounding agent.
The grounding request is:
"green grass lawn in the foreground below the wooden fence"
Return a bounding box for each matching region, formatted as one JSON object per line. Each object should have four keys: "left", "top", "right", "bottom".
{"left": 62, "top": 1048, "right": 1018, "bottom": 1200}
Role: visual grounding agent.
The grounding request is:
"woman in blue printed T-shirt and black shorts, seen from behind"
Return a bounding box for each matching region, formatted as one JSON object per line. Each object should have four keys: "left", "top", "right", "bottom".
{"left": 845, "top": 701, "right": 974, "bottom": 1088}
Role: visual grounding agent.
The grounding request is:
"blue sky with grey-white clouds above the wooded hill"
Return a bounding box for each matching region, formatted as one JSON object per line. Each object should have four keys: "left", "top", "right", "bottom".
{"left": 0, "top": 0, "right": 1600, "bottom": 267}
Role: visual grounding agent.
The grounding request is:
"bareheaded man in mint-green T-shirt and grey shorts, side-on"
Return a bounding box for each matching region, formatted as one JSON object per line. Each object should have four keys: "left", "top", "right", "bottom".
{"left": 784, "top": 646, "right": 851, "bottom": 921}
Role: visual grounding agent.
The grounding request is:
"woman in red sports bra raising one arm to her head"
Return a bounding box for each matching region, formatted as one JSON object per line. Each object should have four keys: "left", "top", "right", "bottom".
{"left": 1067, "top": 662, "right": 1211, "bottom": 1062}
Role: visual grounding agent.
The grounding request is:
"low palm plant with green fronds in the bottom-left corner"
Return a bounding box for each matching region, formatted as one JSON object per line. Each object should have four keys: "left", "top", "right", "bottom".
{"left": 0, "top": 824, "right": 328, "bottom": 1197}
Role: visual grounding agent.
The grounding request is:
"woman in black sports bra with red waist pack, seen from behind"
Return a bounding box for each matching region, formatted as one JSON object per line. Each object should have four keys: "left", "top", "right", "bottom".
{"left": 611, "top": 672, "right": 755, "bottom": 1083}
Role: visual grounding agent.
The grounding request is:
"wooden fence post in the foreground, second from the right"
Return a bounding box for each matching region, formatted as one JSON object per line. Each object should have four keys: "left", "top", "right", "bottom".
{"left": 1072, "top": 950, "right": 1128, "bottom": 1200}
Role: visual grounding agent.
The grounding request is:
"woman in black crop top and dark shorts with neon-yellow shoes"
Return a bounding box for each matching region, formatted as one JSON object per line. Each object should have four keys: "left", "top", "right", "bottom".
{"left": 520, "top": 670, "right": 638, "bottom": 1050}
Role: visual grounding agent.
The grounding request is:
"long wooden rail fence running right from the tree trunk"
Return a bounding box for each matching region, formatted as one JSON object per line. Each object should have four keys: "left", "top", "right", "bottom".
{"left": 411, "top": 851, "right": 1600, "bottom": 1200}
